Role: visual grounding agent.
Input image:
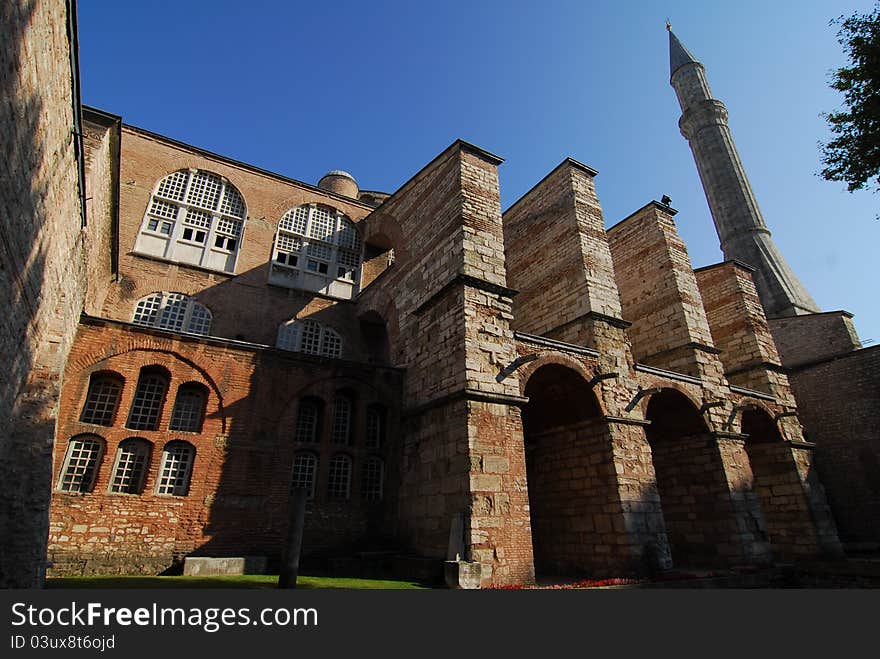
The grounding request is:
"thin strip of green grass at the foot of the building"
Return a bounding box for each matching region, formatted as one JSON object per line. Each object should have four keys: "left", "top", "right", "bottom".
{"left": 46, "top": 574, "right": 428, "bottom": 590}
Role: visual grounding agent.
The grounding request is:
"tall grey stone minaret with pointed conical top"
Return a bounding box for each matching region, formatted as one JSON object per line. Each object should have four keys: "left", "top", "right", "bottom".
{"left": 666, "top": 23, "right": 819, "bottom": 318}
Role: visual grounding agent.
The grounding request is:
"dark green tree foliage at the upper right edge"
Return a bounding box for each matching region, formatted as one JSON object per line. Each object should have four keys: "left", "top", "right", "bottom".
{"left": 820, "top": 2, "right": 880, "bottom": 192}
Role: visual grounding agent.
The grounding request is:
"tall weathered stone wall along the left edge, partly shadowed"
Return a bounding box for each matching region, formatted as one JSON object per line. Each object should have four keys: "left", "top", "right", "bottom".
{"left": 0, "top": 0, "right": 95, "bottom": 588}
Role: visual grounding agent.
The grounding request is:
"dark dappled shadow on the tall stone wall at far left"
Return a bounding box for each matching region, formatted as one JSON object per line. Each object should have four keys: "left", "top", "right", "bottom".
{"left": 0, "top": 2, "right": 61, "bottom": 588}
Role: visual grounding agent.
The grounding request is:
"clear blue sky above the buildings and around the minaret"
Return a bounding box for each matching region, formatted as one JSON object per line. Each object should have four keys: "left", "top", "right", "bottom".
{"left": 78, "top": 0, "right": 880, "bottom": 343}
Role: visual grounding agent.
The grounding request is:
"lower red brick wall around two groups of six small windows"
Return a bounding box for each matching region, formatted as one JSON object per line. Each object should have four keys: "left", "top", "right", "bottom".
{"left": 49, "top": 321, "right": 400, "bottom": 574}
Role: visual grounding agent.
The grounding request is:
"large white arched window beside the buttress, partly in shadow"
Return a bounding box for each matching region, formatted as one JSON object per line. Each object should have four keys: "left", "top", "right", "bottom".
{"left": 269, "top": 204, "right": 361, "bottom": 299}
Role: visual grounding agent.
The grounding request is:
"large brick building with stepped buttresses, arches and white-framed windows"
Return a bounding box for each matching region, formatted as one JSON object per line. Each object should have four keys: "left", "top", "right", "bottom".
{"left": 4, "top": 3, "right": 868, "bottom": 586}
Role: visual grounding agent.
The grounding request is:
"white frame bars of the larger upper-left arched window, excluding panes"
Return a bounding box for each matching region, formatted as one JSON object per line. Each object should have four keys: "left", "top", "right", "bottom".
{"left": 134, "top": 169, "right": 247, "bottom": 273}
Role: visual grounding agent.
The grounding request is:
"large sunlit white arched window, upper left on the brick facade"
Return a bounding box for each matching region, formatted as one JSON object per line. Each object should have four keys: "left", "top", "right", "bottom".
{"left": 134, "top": 169, "right": 245, "bottom": 272}
